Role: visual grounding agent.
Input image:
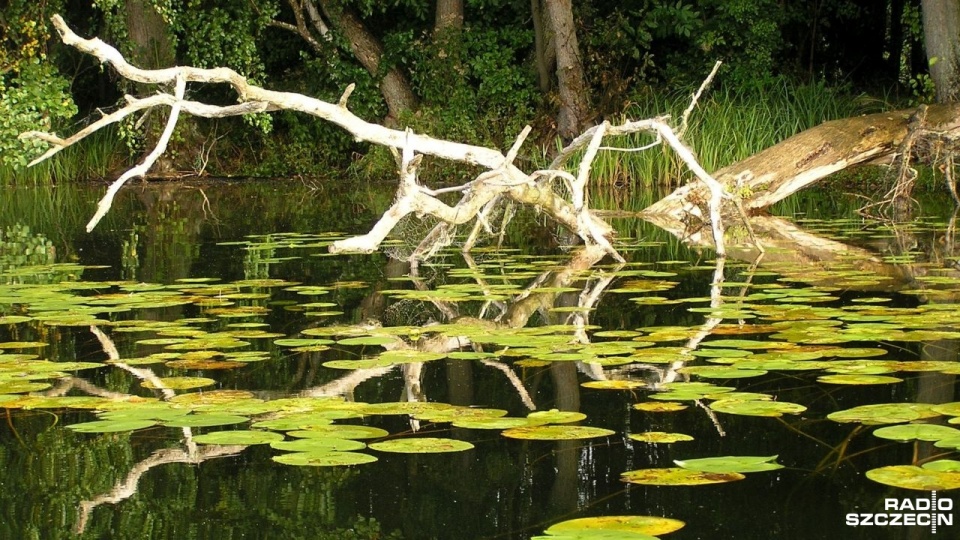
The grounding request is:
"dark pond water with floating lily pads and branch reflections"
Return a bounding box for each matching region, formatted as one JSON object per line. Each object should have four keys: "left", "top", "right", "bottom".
{"left": 0, "top": 182, "right": 960, "bottom": 540}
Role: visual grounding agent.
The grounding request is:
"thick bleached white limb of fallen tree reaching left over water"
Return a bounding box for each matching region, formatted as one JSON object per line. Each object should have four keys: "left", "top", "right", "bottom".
{"left": 22, "top": 15, "right": 622, "bottom": 260}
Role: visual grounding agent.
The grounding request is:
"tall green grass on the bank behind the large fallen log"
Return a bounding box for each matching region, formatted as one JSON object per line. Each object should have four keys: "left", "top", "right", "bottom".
{"left": 576, "top": 81, "right": 884, "bottom": 186}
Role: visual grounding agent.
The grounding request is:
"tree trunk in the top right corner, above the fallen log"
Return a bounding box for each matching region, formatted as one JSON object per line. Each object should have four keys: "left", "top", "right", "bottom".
{"left": 922, "top": 0, "right": 960, "bottom": 103}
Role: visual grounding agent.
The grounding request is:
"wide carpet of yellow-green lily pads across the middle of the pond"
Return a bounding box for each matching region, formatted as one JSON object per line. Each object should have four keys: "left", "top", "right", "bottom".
{"left": 0, "top": 223, "right": 960, "bottom": 498}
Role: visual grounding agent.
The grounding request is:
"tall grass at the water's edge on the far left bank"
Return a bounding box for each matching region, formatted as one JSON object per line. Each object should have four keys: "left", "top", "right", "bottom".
{"left": 0, "top": 129, "right": 127, "bottom": 186}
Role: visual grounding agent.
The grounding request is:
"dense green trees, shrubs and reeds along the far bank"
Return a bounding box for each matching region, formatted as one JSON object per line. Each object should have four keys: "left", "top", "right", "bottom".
{"left": 0, "top": 0, "right": 934, "bottom": 185}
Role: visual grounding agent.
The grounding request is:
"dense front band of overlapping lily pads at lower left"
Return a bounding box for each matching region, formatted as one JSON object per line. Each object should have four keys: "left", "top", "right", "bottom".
{"left": 43, "top": 390, "right": 614, "bottom": 466}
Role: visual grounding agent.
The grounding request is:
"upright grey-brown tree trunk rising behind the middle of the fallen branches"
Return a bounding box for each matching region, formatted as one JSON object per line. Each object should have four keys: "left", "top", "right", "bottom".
{"left": 543, "top": 0, "right": 590, "bottom": 140}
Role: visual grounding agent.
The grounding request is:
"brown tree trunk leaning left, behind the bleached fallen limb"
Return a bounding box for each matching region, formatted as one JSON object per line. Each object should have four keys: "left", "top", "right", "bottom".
{"left": 319, "top": 0, "right": 417, "bottom": 125}
